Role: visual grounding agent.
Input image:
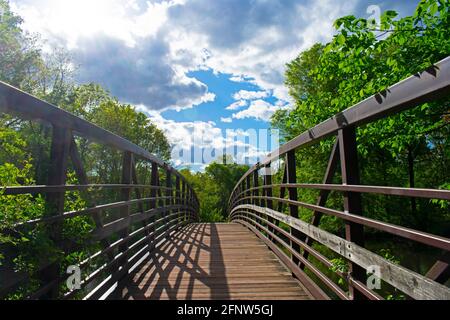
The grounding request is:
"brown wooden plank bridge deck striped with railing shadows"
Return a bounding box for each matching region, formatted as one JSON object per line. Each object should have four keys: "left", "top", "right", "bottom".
{"left": 120, "top": 223, "right": 311, "bottom": 300}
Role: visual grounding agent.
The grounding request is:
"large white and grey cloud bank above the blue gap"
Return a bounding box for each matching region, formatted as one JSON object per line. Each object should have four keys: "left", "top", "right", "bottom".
{"left": 11, "top": 0, "right": 359, "bottom": 110}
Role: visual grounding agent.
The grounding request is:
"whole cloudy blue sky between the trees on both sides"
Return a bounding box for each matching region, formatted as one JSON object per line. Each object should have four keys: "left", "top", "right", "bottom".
{"left": 10, "top": 0, "right": 418, "bottom": 169}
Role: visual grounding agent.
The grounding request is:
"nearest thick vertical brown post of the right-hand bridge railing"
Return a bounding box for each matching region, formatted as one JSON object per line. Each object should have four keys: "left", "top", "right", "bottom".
{"left": 338, "top": 126, "right": 366, "bottom": 299}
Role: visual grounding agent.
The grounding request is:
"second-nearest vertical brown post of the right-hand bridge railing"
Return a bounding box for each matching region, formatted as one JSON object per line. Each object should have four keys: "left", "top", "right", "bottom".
{"left": 286, "top": 150, "right": 303, "bottom": 265}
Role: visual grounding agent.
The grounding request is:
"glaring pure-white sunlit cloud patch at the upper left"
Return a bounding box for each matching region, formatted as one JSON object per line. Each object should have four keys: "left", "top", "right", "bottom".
{"left": 12, "top": 0, "right": 181, "bottom": 48}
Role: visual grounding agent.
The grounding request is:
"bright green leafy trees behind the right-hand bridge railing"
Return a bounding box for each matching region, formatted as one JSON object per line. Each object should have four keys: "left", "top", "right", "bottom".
{"left": 272, "top": 0, "right": 450, "bottom": 235}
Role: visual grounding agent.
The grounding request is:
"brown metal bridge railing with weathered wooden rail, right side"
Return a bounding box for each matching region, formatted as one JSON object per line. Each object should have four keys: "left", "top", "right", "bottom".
{"left": 229, "top": 57, "right": 450, "bottom": 300}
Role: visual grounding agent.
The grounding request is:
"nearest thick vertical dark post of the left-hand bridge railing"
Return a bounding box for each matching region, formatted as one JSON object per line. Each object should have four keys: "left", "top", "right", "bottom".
{"left": 40, "top": 126, "right": 72, "bottom": 299}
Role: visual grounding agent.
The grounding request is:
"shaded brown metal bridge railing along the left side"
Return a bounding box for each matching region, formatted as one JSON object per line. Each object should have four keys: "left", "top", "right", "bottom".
{"left": 0, "top": 82, "right": 199, "bottom": 299}
